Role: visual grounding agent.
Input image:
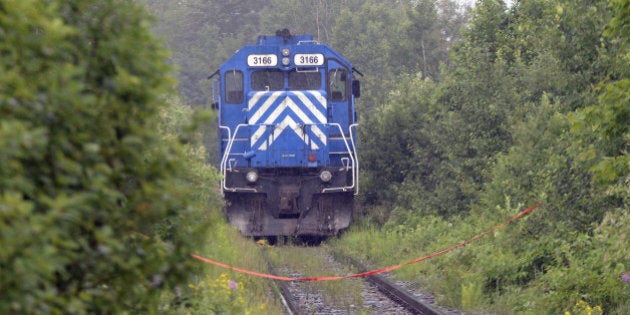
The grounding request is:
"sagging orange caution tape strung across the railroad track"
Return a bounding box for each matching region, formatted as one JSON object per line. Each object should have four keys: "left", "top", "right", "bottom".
{"left": 191, "top": 202, "right": 542, "bottom": 281}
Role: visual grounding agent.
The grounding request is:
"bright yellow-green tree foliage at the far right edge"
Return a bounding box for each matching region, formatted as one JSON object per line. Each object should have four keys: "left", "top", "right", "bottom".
{"left": 571, "top": 0, "right": 630, "bottom": 188}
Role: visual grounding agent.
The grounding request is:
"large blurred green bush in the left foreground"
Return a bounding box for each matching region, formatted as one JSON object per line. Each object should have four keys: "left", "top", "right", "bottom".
{"left": 0, "top": 0, "right": 212, "bottom": 314}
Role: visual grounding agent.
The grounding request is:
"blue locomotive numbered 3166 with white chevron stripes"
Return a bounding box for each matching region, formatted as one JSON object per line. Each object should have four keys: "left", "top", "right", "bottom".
{"left": 214, "top": 29, "right": 360, "bottom": 237}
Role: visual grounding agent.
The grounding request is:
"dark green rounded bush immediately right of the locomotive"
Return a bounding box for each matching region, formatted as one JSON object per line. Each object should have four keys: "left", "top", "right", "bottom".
{"left": 360, "top": 74, "right": 439, "bottom": 211}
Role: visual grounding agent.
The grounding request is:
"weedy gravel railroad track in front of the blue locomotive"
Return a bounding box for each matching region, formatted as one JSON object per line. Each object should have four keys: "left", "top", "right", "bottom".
{"left": 261, "top": 248, "right": 450, "bottom": 315}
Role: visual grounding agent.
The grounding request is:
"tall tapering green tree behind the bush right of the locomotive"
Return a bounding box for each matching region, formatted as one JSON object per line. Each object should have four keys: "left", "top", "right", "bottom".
{"left": 410, "top": 1, "right": 517, "bottom": 216}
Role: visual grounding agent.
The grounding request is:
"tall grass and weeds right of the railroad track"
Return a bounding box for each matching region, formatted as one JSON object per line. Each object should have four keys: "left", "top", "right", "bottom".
{"left": 332, "top": 203, "right": 630, "bottom": 314}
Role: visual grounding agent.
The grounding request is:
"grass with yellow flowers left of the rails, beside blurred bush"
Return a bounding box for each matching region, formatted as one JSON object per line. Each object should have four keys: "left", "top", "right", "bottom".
{"left": 161, "top": 201, "right": 282, "bottom": 314}
